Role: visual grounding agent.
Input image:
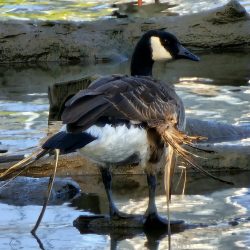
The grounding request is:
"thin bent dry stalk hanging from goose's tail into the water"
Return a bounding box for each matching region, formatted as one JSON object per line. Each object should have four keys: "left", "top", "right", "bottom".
{"left": 31, "top": 149, "right": 60, "bottom": 235}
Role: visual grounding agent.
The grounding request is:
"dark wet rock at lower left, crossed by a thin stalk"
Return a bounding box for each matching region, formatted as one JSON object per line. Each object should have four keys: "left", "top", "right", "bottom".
{"left": 0, "top": 177, "right": 80, "bottom": 206}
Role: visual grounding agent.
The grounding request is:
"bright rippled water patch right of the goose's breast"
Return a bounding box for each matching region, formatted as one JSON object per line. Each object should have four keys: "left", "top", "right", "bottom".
{"left": 176, "top": 80, "right": 250, "bottom": 125}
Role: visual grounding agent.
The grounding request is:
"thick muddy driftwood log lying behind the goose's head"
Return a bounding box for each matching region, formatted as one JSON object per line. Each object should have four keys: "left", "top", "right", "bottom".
{"left": 0, "top": 0, "right": 250, "bottom": 63}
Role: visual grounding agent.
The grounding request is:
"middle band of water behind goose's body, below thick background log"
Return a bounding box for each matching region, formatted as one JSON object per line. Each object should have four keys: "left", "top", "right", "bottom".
{"left": 0, "top": 51, "right": 250, "bottom": 154}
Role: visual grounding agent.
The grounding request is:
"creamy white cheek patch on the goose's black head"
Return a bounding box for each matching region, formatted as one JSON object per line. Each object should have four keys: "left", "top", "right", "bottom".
{"left": 150, "top": 36, "right": 172, "bottom": 61}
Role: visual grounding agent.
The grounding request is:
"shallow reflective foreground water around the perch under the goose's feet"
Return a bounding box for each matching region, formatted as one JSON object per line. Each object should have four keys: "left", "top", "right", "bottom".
{"left": 0, "top": 173, "right": 250, "bottom": 250}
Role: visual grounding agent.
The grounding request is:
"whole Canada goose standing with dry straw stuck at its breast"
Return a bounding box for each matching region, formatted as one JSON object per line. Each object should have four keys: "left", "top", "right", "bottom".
{"left": 1, "top": 30, "right": 230, "bottom": 229}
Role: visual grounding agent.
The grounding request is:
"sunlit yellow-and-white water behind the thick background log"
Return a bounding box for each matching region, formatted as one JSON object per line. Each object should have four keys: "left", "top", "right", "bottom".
{"left": 0, "top": 0, "right": 250, "bottom": 21}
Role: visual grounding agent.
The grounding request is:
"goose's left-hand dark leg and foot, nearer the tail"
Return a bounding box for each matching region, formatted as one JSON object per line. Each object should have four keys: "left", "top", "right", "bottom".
{"left": 100, "top": 168, "right": 131, "bottom": 219}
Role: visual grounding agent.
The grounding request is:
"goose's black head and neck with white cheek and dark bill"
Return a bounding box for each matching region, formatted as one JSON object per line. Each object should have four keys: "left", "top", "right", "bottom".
{"left": 131, "top": 30, "right": 200, "bottom": 76}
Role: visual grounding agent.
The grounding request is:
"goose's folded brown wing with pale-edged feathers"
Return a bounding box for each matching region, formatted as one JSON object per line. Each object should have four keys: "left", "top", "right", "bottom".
{"left": 62, "top": 75, "right": 184, "bottom": 132}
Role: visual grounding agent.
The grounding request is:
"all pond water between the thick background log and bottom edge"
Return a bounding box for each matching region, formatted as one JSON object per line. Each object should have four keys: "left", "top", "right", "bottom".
{"left": 0, "top": 51, "right": 250, "bottom": 250}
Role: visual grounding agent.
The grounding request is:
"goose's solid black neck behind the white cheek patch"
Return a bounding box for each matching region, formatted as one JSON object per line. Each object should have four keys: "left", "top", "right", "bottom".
{"left": 130, "top": 38, "right": 154, "bottom": 76}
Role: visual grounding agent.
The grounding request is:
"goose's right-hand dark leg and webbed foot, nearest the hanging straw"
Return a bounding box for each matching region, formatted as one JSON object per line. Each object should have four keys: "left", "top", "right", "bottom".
{"left": 144, "top": 174, "right": 167, "bottom": 228}
